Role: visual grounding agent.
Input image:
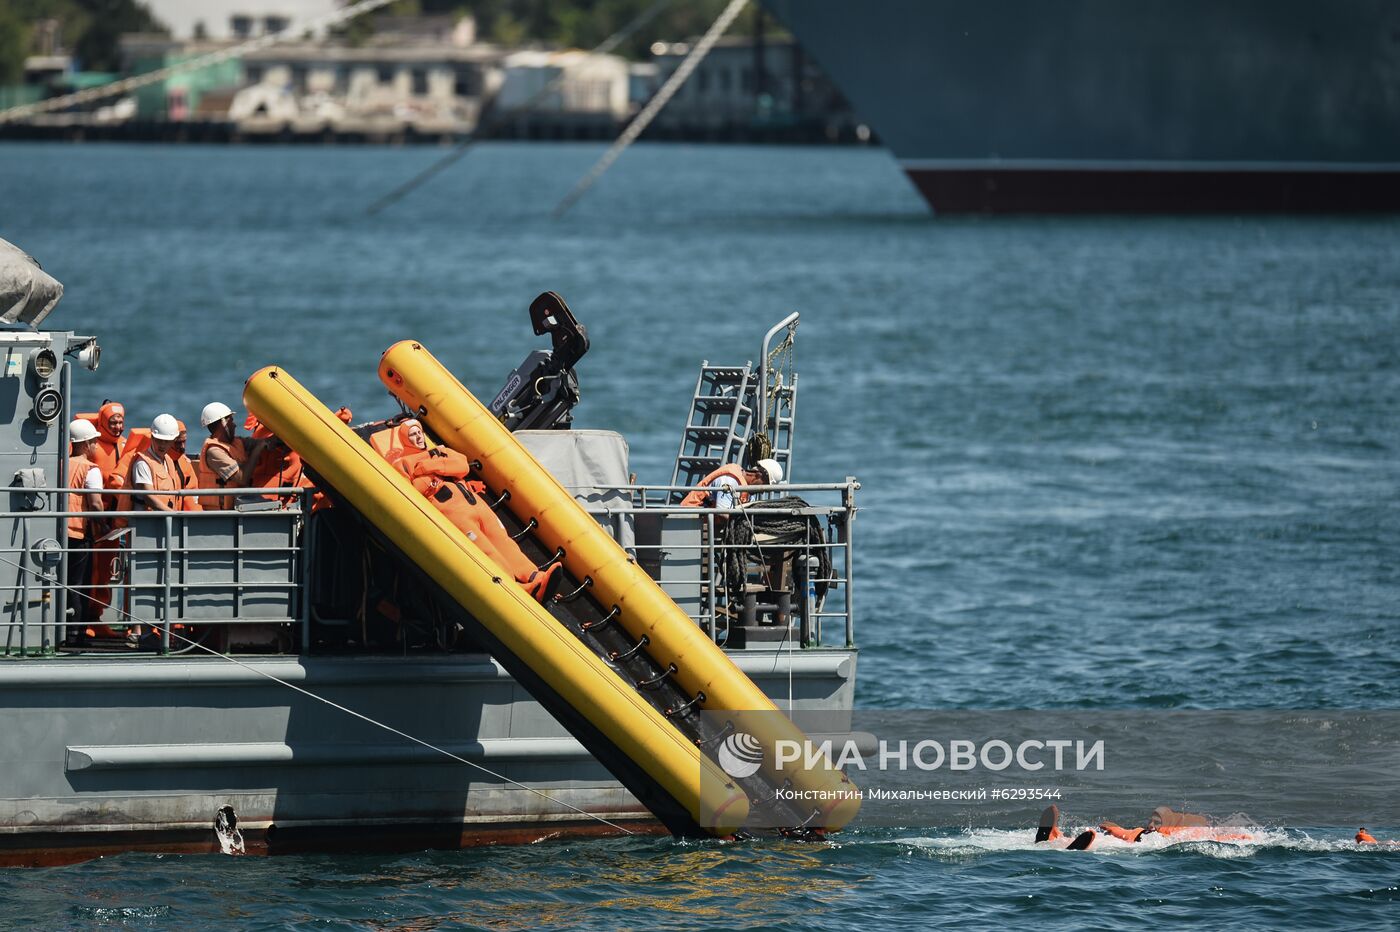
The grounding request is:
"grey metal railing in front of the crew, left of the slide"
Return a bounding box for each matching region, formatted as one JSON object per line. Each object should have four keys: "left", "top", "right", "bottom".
{"left": 0, "top": 488, "right": 312, "bottom": 656}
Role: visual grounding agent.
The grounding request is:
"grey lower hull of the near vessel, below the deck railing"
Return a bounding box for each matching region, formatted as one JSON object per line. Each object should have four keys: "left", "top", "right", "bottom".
{"left": 0, "top": 648, "right": 855, "bottom": 866}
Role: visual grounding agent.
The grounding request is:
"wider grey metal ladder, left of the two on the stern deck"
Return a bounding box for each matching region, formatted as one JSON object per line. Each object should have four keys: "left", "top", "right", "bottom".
{"left": 671, "top": 360, "right": 757, "bottom": 501}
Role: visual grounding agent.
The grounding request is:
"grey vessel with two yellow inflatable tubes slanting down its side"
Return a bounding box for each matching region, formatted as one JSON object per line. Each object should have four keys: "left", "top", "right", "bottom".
{"left": 0, "top": 243, "right": 858, "bottom": 865}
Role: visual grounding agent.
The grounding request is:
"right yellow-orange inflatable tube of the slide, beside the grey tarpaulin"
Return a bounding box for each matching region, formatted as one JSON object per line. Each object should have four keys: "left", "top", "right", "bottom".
{"left": 379, "top": 340, "right": 860, "bottom": 828}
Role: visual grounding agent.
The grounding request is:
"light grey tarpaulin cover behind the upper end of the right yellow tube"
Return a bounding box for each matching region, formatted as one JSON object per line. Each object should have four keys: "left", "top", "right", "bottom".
{"left": 515, "top": 431, "right": 637, "bottom": 551}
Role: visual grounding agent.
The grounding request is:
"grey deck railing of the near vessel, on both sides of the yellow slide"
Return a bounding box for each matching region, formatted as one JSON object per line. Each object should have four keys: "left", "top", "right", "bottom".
{"left": 0, "top": 479, "right": 860, "bottom": 656}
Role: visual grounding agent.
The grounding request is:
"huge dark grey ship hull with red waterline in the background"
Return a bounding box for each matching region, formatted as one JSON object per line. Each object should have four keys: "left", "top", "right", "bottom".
{"left": 763, "top": 0, "right": 1400, "bottom": 213}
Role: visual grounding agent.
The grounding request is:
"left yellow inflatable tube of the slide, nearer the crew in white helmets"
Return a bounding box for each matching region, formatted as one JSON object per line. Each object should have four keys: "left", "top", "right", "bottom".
{"left": 244, "top": 367, "right": 749, "bottom": 835}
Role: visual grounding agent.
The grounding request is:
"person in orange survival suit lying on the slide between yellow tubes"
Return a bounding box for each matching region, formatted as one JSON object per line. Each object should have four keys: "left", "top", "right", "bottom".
{"left": 388, "top": 418, "right": 559, "bottom": 602}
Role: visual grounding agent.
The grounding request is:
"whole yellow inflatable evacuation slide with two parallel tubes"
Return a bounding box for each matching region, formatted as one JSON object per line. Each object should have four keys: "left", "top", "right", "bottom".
{"left": 244, "top": 341, "right": 860, "bottom": 837}
